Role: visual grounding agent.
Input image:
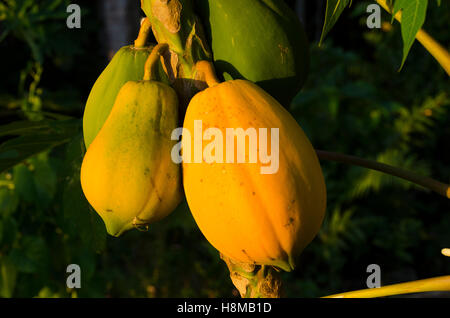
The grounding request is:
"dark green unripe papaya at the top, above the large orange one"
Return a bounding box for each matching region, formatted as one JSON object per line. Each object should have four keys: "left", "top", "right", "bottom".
{"left": 195, "top": 0, "right": 309, "bottom": 107}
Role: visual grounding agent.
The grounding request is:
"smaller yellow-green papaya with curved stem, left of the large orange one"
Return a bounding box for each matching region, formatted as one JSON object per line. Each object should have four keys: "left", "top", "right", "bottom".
{"left": 81, "top": 44, "right": 182, "bottom": 236}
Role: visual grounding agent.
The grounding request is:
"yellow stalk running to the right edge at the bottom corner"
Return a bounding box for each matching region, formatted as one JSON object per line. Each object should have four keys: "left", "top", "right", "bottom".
{"left": 322, "top": 276, "right": 450, "bottom": 298}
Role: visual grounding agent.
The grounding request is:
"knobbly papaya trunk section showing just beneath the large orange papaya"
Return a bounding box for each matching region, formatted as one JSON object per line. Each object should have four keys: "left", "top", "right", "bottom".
{"left": 220, "top": 254, "right": 281, "bottom": 298}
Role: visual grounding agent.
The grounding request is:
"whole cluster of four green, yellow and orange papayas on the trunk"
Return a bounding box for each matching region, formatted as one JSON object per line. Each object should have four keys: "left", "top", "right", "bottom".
{"left": 81, "top": 0, "right": 326, "bottom": 271}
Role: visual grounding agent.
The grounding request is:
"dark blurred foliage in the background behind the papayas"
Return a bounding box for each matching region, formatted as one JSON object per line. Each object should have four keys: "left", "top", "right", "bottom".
{"left": 0, "top": 0, "right": 450, "bottom": 297}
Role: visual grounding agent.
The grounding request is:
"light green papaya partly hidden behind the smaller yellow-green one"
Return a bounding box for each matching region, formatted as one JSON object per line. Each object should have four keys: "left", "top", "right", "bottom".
{"left": 83, "top": 22, "right": 168, "bottom": 148}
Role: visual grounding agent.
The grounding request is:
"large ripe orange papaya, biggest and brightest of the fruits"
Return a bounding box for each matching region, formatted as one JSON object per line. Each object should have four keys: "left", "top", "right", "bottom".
{"left": 182, "top": 61, "right": 326, "bottom": 271}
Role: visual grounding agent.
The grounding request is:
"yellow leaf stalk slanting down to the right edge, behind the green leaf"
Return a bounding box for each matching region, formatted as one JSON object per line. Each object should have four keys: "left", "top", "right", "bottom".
{"left": 376, "top": 0, "right": 450, "bottom": 75}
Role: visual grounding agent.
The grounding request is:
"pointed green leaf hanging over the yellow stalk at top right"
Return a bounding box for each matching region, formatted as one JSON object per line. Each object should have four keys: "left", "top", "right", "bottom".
{"left": 392, "top": 0, "right": 428, "bottom": 69}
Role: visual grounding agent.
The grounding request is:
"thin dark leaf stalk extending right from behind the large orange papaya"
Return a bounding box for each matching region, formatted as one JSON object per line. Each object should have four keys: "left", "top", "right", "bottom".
{"left": 316, "top": 150, "right": 450, "bottom": 199}
